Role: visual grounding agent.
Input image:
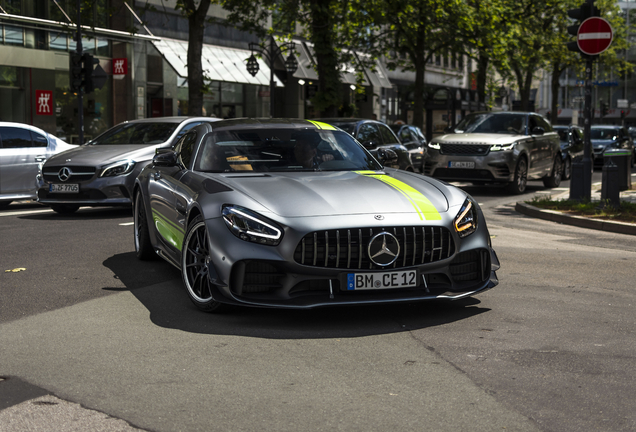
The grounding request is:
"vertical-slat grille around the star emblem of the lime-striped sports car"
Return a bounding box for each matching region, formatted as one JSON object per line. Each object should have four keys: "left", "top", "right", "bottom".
{"left": 294, "top": 226, "right": 455, "bottom": 270}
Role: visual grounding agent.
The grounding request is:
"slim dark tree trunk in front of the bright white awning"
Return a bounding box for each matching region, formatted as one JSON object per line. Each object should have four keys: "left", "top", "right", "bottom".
{"left": 184, "top": 0, "right": 210, "bottom": 116}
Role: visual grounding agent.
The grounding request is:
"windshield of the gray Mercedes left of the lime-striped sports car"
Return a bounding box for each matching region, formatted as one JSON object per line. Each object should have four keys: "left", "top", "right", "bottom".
{"left": 87, "top": 122, "right": 179, "bottom": 145}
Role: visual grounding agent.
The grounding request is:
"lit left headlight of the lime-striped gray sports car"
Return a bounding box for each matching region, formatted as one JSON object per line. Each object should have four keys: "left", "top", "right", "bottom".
{"left": 221, "top": 205, "right": 283, "bottom": 246}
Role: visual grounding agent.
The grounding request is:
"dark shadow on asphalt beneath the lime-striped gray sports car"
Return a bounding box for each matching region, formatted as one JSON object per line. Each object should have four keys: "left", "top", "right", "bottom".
{"left": 104, "top": 253, "right": 489, "bottom": 339}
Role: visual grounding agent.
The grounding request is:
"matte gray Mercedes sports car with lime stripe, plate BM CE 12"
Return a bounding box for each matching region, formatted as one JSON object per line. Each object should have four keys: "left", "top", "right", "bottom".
{"left": 133, "top": 119, "right": 499, "bottom": 312}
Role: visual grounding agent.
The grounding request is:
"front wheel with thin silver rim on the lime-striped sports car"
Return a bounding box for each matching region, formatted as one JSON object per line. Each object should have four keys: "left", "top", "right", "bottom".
{"left": 181, "top": 215, "right": 226, "bottom": 313}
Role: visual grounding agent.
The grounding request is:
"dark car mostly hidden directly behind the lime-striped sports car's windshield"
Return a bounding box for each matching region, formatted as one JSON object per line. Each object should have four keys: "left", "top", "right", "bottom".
{"left": 318, "top": 118, "right": 415, "bottom": 171}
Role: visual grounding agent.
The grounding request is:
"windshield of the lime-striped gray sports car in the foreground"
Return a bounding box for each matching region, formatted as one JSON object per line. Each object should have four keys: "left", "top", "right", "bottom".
{"left": 194, "top": 129, "right": 382, "bottom": 172}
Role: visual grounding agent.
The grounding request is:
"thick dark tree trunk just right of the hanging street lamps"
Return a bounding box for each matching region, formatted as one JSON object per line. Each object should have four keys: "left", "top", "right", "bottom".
{"left": 310, "top": 0, "right": 342, "bottom": 117}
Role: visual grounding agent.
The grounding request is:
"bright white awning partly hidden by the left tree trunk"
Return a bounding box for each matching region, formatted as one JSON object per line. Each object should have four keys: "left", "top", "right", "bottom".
{"left": 152, "top": 39, "right": 283, "bottom": 87}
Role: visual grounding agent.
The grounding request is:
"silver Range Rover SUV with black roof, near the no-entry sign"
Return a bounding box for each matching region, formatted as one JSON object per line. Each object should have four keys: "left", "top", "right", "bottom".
{"left": 425, "top": 112, "right": 563, "bottom": 194}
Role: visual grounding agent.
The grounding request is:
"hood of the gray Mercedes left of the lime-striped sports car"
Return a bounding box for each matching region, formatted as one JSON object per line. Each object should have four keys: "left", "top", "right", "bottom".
{"left": 47, "top": 144, "right": 160, "bottom": 165}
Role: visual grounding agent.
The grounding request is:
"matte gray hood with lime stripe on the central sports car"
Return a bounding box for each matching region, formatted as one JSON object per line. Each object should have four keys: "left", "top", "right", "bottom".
{"left": 219, "top": 170, "right": 452, "bottom": 216}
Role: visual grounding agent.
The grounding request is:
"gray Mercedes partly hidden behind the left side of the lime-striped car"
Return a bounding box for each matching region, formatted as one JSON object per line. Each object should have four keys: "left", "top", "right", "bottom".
{"left": 37, "top": 117, "right": 218, "bottom": 213}
